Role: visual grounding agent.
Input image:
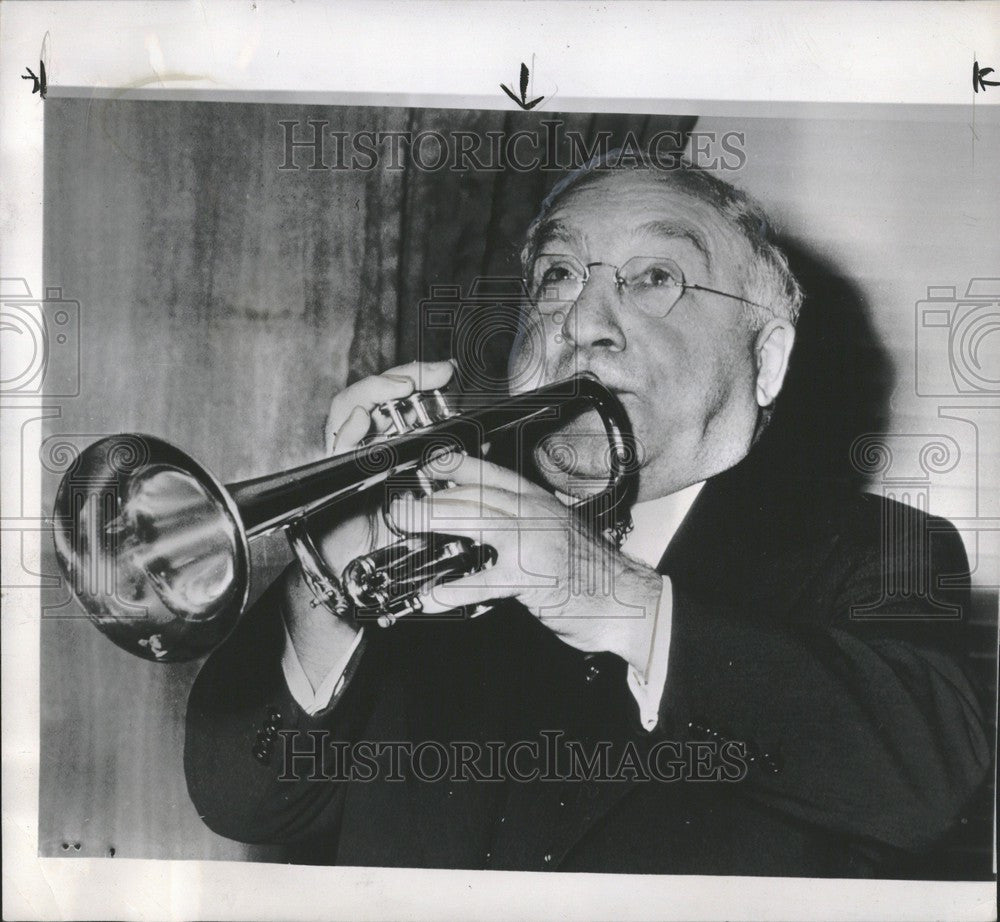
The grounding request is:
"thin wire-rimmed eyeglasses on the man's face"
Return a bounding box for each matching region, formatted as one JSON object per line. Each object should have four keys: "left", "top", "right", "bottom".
{"left": 524, "top": 253, "right": 762, "bottom": 317}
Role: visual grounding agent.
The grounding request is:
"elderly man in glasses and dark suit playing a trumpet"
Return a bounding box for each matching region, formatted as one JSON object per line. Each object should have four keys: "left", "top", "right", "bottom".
{"left": 186, "top": 164, "right": 989, "bottom": 876}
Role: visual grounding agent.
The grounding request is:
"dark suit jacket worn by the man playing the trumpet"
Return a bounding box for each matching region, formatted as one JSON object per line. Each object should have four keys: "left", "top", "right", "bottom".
{"left": 185, "top": 455, "right": 990, "bottom": 876}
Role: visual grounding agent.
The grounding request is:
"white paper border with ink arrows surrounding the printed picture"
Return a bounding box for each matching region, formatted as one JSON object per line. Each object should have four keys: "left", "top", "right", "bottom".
{"left": 0, "top": 0, "right": 1000, "bottom": 919}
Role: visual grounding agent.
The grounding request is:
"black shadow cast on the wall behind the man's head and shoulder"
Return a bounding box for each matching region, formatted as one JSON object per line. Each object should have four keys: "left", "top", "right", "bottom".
{"left": 757, "top": 241, "right": 997, "bottom": 880}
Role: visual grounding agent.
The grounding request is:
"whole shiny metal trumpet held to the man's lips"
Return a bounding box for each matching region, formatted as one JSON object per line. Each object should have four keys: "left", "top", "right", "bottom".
{"left": 53, "top": 373, "right": 637, "bottom": 663}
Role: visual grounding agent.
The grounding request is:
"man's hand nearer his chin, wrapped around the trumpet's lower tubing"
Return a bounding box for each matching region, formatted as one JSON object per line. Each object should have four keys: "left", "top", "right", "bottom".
{"left": 397, "top": 456, "right": 663, "bottom": 674}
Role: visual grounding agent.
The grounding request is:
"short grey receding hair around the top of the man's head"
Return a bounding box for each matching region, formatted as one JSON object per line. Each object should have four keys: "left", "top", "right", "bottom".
{"left": 521, "top": 150, "right": 803, "bottom": 331}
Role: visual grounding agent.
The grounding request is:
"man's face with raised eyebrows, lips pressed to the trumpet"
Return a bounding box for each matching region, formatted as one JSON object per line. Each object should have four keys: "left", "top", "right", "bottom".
{"left": 511, "top": 171, "right": 758, "bottom": 500}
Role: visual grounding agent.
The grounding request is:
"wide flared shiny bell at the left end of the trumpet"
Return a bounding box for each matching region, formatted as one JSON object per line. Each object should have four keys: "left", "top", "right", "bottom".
{"left": 54, "top": 435, "right": 250, "bottom": 663}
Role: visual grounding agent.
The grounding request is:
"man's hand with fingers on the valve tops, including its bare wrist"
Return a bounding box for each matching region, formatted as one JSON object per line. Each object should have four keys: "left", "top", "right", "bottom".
{"left": 285, "top": 361, "right": 455, "bottom": 688}
